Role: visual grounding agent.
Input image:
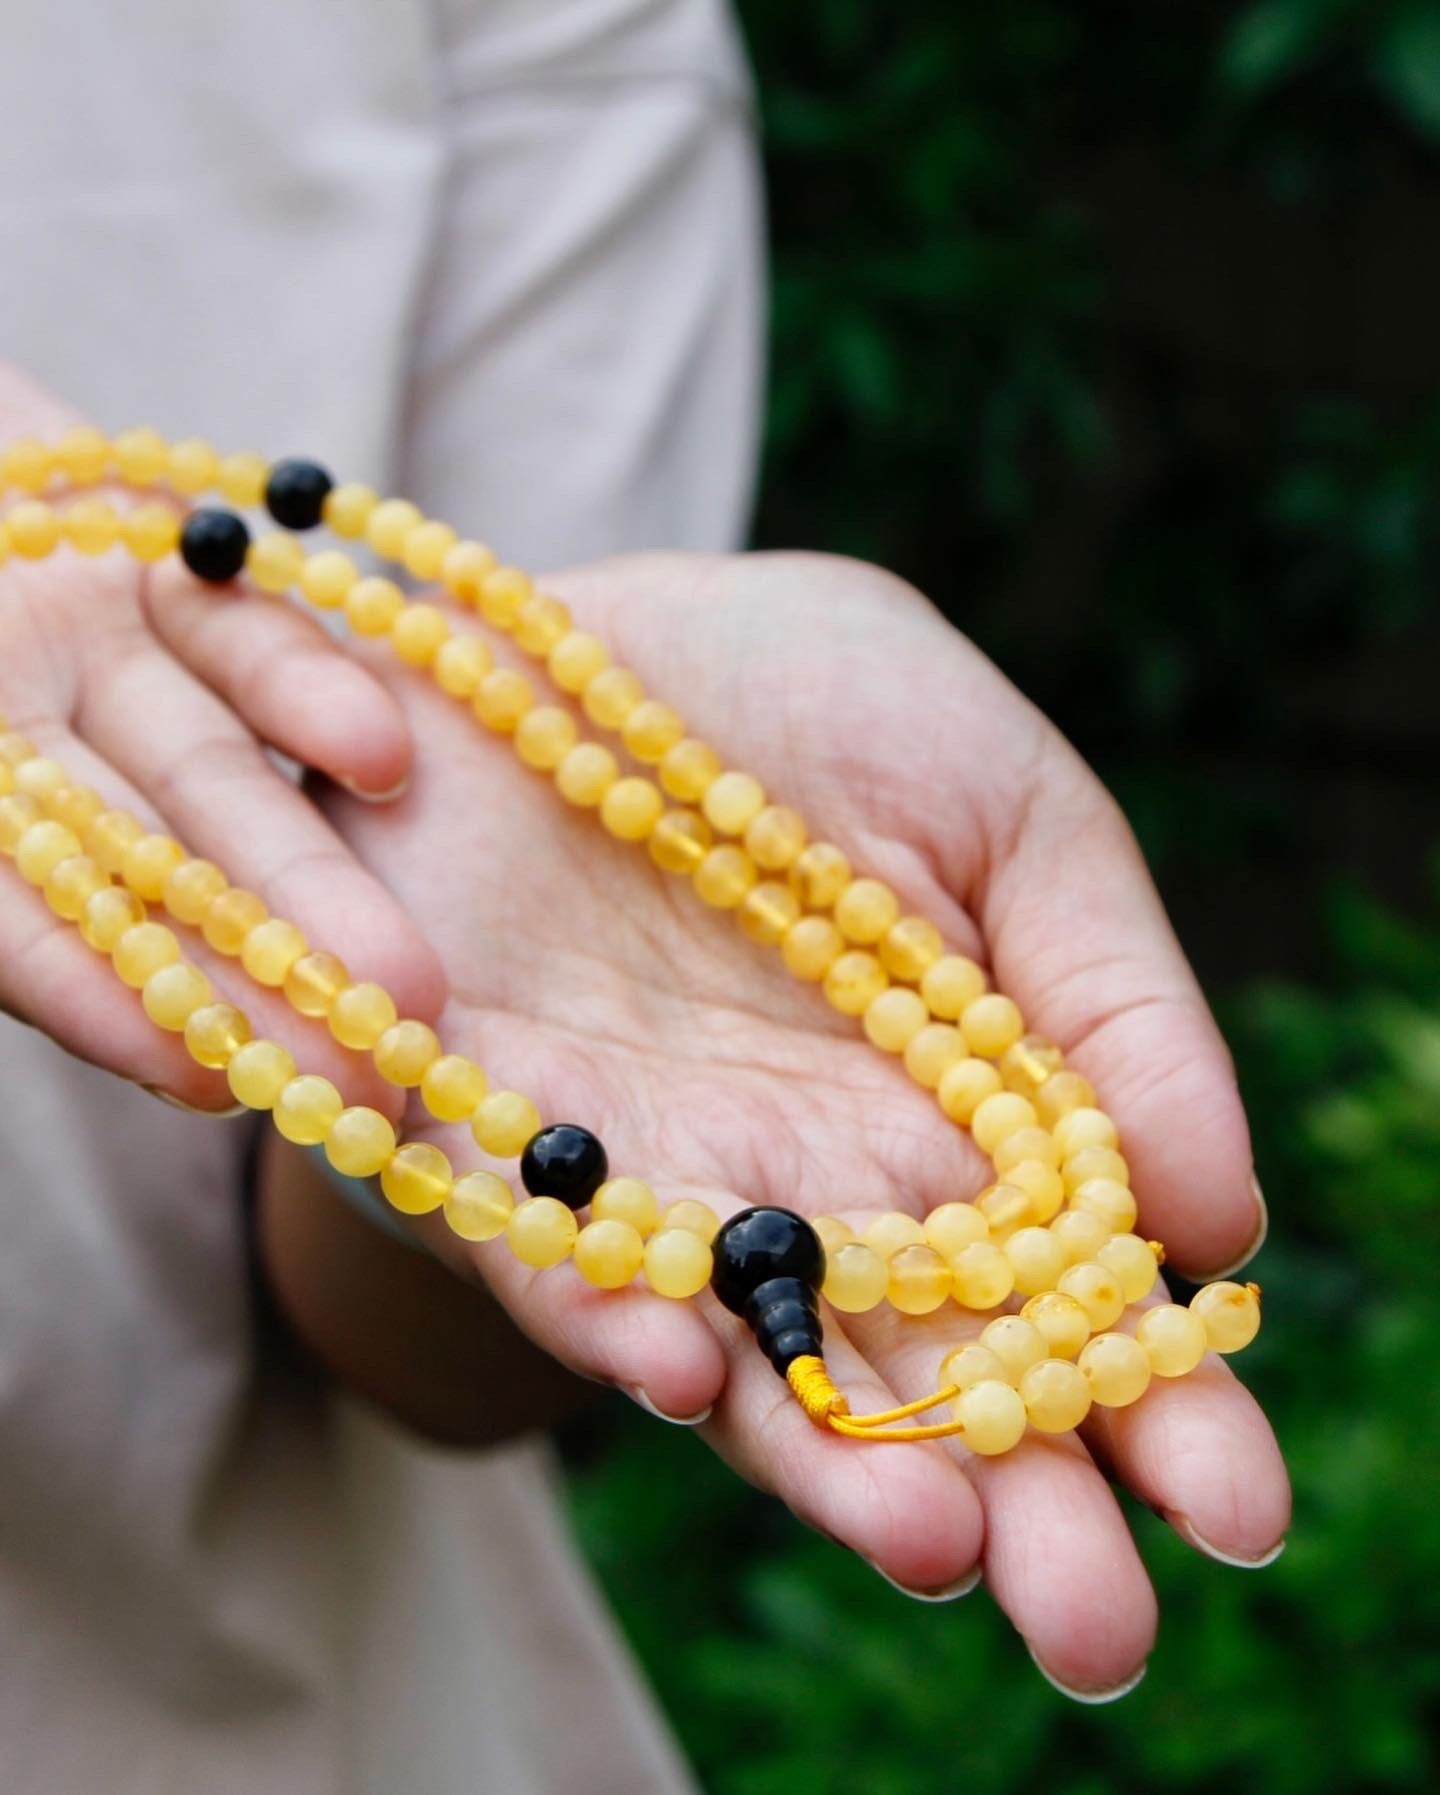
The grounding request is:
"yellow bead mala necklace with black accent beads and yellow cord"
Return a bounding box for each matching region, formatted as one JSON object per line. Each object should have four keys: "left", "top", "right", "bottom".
{"left": 0, "top": 429, "right": 1260, "bottom": 1454}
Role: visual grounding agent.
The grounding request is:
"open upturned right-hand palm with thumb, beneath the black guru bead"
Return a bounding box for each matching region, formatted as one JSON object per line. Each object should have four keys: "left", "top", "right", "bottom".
{"left": 319, "top": 556, "right": 1289, "bottom": 1691}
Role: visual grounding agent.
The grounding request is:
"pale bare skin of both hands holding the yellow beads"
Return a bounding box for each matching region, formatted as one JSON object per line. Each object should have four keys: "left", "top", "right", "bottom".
{"left": 0, "top": 364, "right": 1289, "bottom": 1691}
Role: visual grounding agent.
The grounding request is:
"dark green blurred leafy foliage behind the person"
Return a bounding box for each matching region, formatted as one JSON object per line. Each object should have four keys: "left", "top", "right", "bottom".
{"left": 569, "top": 0, "right": 1440, "bottom": 1795}
